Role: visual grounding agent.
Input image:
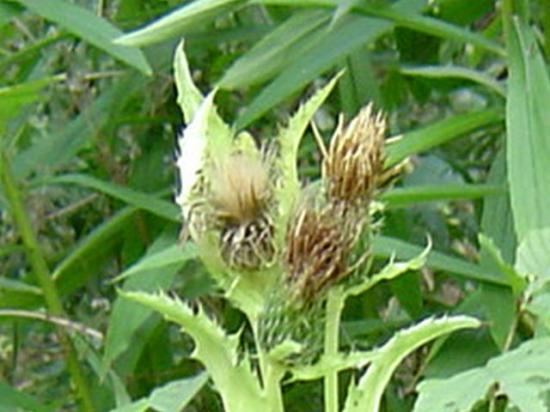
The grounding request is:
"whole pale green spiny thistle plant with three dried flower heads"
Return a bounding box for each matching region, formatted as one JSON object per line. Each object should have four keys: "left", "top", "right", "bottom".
{"left": 122, "top": 41, "right": 479, "bottom": 412}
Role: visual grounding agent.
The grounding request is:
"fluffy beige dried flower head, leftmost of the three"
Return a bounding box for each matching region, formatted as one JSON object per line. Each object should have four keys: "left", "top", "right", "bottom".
{"left": 208, "top": 153, "right": 275, "bottom": 269}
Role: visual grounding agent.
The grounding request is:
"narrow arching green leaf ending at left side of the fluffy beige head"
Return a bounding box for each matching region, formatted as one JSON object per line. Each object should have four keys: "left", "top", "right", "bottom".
{"left": 34, "top": 174, "right": 180, "bottom": 222}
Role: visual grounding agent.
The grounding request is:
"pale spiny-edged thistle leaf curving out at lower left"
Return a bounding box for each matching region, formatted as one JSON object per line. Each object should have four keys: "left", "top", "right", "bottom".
{"left": 120, "top": 292, "right": 265, "bottom": 412}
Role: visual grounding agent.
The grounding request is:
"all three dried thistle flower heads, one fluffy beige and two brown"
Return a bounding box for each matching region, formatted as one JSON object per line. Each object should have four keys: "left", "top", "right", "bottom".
{"left": 178, "top": 101, "right": 386, "bottom": 303}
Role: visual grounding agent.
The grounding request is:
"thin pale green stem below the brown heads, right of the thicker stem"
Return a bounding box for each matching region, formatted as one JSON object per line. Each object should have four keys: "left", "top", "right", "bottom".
{"left": 323, "top": 286, "right": 344, "bottom": 412}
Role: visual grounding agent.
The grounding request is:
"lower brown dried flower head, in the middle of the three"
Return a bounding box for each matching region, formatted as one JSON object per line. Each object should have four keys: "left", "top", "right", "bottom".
{"left": 284, "top": 204, "right": 358, "bottom": 303}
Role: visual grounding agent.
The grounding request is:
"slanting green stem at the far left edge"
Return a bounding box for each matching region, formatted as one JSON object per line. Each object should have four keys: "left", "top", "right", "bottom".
{"left": 0, "top": 151, "right": 95, "bottom": 412}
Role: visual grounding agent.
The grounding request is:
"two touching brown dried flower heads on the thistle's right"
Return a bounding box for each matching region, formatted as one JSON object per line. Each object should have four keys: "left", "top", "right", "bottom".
{"left": 284, "top": 105, "right": 386, "bottom": 304}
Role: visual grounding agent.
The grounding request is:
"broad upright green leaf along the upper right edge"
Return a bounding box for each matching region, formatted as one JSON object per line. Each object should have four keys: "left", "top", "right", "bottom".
{"left": 506, "top": 19, "right": 550, "bottom": 242}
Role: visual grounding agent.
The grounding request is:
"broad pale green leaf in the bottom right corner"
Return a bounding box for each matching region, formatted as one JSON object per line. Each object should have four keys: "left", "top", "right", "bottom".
{"left": 414, "top": 338, "right": 550, "bottom": 412}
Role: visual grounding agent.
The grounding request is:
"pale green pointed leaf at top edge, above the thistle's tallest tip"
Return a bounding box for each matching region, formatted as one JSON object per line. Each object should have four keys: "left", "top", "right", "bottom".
{"left": 116, "top": 0, "right": 243, "bottom": 46}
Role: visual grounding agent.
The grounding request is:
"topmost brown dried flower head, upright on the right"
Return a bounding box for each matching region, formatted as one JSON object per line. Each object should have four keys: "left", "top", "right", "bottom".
{"left": 322, "top": 104, "right": 386, "bottom": 205}
